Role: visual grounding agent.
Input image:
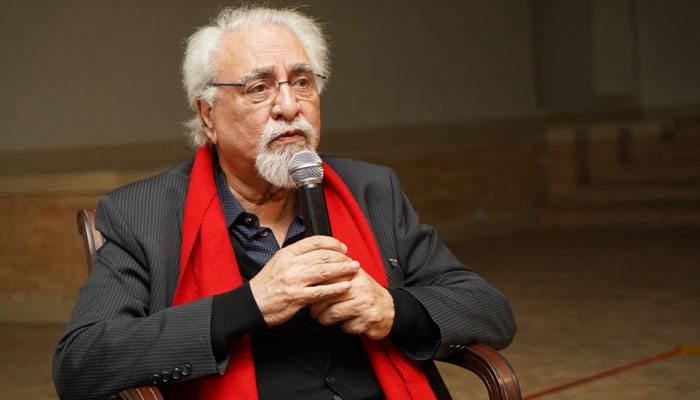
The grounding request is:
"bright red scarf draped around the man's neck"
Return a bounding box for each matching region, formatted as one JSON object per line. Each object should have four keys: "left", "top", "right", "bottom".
{"left": 173, "top": 146, "right": 435, "bottom": 400}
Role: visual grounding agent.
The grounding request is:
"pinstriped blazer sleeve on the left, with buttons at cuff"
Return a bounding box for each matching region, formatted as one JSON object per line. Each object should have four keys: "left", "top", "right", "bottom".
{"left": 53, "top": 191, "right": 225, "bottom": 399}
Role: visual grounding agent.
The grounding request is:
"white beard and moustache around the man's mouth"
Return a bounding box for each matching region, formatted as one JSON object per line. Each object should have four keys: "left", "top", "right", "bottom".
{"left": 255, "top": 117, "right": 318, "bottom": 189}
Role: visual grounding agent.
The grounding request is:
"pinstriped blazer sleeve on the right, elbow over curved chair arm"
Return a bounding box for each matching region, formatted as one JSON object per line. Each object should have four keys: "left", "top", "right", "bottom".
{"left": 382, "top": 170, "right": 515, "bottom": 359}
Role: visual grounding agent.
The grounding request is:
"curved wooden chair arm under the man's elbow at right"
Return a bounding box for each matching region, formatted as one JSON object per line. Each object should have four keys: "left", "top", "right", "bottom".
{"left": 440, "top": 344, "right": 522, "bottom": 400}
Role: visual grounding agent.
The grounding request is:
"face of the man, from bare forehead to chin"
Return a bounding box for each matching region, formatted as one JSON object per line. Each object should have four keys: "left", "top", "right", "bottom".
{"left": 200, "top": 24, "right": 321, "bottom": 186}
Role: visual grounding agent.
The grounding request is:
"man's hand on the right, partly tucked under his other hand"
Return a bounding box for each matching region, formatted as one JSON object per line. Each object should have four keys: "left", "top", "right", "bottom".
{"left": 311, "top": 269, "right": 394, "bottom": 340}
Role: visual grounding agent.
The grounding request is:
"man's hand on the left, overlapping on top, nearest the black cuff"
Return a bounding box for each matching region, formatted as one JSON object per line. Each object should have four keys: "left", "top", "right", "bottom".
{"left": 250, "top": 236, "right": 360, "bottom": 326}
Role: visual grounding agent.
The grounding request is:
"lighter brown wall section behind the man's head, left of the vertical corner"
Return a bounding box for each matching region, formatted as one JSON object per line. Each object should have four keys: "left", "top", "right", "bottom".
{"left": 0, "top": 0, "right": 534, "bottom": 151}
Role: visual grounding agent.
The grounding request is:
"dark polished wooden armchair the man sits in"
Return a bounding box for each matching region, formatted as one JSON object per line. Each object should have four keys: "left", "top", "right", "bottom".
{"left": 78, "top": 209, "right": 522, "bottom": 400}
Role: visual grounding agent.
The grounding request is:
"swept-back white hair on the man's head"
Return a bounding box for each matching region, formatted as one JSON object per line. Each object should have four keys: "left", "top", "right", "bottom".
{"left": 182, "top": 6, "right": 330, "bottom": 149}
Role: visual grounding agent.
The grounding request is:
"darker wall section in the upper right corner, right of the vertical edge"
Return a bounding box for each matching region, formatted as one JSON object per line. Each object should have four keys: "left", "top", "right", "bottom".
{"left": 531, "top": 0, "right": 700, "bottom": 111}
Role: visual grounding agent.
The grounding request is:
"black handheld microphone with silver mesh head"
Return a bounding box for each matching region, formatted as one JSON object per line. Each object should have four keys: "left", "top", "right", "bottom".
{"left": 289, "top": 150, "right": 332, "bottom": 237}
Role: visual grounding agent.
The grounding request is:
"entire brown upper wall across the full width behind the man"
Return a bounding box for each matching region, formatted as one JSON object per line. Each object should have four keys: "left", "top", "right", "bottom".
{"left": 5, "top": 0, "right": 700, "bottom": 154}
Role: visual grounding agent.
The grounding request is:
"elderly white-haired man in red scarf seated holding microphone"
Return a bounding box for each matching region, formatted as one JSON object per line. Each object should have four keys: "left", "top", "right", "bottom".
{"left": 53, "top": 8, "right": 515, "bottom": 400}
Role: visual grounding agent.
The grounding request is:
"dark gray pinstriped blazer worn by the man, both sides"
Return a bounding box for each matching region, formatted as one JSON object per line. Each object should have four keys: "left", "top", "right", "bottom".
{"left": 53, "top": 157, "right": 515, "bottom": 399}
